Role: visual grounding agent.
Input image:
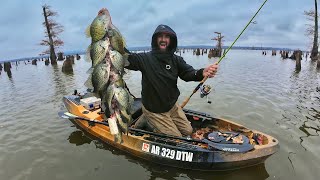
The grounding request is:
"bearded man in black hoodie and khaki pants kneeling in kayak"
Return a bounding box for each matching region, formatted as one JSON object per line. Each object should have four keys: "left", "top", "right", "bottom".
{"left": 126, "top": 25, "right": 218, "bottom": 136}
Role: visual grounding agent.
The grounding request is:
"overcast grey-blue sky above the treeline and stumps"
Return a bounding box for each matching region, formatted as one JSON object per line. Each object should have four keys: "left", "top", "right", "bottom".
{"left": 0, "top": 0, "right": 314, "bottom": 61}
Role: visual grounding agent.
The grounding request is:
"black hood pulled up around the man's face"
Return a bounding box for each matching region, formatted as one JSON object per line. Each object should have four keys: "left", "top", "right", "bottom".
{"left": 151, "top": 24, "right": 178, "bottom": 53}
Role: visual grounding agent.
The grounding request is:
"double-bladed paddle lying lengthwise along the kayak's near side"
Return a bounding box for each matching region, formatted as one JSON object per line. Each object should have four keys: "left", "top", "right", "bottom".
{"left": 58, "top": 112, "right": 253, "bottom": 153}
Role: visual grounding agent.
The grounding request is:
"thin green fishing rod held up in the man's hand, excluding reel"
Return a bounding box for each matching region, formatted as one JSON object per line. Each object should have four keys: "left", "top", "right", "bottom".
{"left": 181, "top": 0, "right": 268, "bottom": 108}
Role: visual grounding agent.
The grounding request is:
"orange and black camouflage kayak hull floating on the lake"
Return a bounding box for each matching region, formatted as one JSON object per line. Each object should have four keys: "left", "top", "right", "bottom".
{"left": 63, "top": 96, "right": 279, "bottom": 170}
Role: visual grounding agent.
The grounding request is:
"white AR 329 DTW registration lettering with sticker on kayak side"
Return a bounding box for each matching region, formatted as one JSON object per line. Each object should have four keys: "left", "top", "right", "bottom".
{"left": 141, "top": 143, "right": 193, "bottom": 162}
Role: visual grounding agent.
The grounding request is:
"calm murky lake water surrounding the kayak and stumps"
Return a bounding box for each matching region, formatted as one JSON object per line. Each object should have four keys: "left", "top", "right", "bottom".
{"left": 0, "top": 50, "right": 320, "bottom": 180}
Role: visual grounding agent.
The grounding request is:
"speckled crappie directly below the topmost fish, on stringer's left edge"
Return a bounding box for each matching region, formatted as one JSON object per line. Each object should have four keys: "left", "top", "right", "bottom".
{"left": 88, "top": 38, "right": 110, "bottom": 67}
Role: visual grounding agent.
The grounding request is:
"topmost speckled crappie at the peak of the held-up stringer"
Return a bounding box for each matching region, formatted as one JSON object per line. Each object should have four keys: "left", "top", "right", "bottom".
{"left": 86, "top": 8, "right": 111, "bottom": 42}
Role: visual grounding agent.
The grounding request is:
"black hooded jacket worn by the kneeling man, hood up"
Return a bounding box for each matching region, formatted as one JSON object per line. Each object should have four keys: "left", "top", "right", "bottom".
{"left": 126, "top": 25, "right": 203, "bottom": 113}
